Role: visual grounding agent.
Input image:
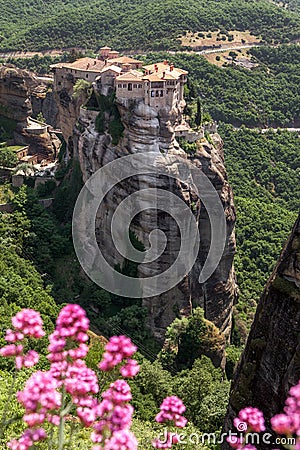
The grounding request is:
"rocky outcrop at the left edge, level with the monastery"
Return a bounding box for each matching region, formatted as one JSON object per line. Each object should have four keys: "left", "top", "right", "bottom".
{"left": 0, "top": 66, "right": 34, "bottom": 122}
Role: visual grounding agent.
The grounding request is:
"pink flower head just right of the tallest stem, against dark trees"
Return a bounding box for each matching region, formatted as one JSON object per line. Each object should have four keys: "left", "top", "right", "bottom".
{"left": 98, "top": 336, "right": 139, "bottom": 378}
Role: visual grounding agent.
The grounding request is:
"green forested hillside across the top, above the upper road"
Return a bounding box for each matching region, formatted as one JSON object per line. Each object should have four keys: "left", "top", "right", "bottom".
{"left": 0, "top": 0, "right": 300, "bottom": 51}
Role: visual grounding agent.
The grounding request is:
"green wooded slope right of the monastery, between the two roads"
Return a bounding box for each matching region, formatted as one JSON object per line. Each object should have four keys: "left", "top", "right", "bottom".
{"left": 142, "top": 45, "right": 300, "bottom": 127}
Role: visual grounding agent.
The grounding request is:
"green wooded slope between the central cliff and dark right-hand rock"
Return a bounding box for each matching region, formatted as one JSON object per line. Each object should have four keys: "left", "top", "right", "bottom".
{"left": 219, "top": 125, "right": 300, "bottom": 332}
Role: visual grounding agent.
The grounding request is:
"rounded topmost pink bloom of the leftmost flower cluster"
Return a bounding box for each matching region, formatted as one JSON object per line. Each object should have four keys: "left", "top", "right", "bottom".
{"left": 9, "top": 309, "right": 45, "bottom": 338}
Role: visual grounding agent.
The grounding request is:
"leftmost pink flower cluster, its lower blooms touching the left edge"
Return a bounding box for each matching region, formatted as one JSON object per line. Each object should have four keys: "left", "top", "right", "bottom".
{"left": 0, "top": 309, "right": 45, "bottom": 370}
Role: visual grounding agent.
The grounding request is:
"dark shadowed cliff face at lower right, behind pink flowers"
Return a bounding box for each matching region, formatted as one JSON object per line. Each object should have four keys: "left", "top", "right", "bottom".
{"left": 223, "top": 216, "right": 300, "bottom": 450}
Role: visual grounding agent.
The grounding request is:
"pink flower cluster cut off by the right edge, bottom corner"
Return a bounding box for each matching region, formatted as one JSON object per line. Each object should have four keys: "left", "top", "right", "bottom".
{"left": 271, "top": 382, "right": 300, "bottom": 449}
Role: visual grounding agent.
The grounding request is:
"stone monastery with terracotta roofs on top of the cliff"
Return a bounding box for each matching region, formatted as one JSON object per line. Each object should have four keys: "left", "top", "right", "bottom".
{"left": 51, "top": 47, "right": 188, "bottom": 109}
